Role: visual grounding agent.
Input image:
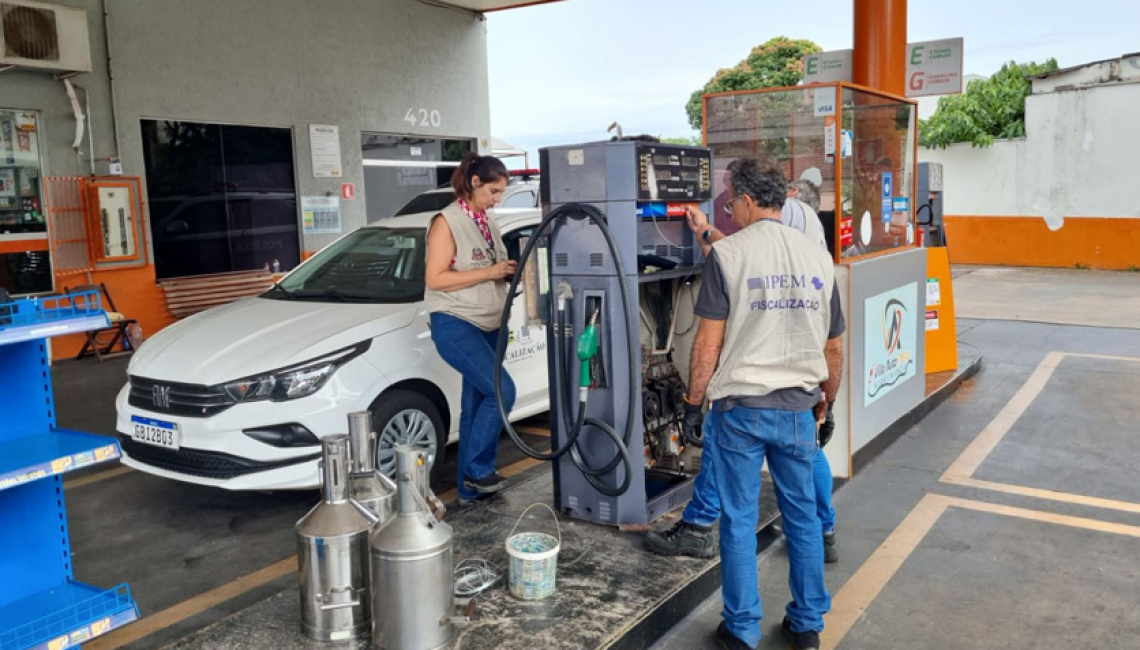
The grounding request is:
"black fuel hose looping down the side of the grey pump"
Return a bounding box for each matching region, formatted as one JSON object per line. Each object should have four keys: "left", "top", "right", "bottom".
{"left": 495, "top": 203, "right": 640, "bottom": 496}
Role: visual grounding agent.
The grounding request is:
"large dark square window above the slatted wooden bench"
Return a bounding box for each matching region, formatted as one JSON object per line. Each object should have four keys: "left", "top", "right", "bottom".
{"left": 143, "top": 120, "right": 301, "bottom": 279}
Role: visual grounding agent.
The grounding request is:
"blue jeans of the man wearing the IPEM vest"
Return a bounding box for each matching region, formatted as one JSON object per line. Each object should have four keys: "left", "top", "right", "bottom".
{"left": 705, "top": 406, "right": 831, "bottom": 647}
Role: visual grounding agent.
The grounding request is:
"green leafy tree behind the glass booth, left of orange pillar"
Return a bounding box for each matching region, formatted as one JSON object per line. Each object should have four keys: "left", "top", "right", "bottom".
{"left": 685, "top": 36, "right": 823, "bottom": 131}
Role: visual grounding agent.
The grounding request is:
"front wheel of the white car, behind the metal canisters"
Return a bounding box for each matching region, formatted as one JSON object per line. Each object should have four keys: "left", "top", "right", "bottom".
{"left": 372, "top": 390, "right": 447, "bottom": 479}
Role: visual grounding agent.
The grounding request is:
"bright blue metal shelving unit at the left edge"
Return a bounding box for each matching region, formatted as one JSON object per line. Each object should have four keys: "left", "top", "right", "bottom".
{"left": 0, "top": 292, "right": 139, "bottom": 650}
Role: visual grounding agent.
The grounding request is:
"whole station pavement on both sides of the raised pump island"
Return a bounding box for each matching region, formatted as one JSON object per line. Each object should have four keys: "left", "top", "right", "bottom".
{"left": 46, "top": 264, "right": 1140, "bottom": 650}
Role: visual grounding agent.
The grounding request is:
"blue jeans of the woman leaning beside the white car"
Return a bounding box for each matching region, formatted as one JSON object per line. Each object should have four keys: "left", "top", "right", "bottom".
{"left": 431, "top": 314, "right": 515, "bottom": 499}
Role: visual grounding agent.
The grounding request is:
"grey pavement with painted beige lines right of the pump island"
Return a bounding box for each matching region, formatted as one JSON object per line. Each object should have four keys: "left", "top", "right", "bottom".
{"left": 653, "top": 312, "right": 1140, "bottom": 650}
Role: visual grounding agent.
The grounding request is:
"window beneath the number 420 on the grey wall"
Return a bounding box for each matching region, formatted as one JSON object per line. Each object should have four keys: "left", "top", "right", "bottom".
{"left": 360, "top": 133, "right": 474, "bottom": 224}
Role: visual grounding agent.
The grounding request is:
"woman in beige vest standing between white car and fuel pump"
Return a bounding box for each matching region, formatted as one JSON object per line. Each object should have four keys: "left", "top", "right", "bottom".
{"left": 425, "top": 153, "right": 515, "bottom": 505}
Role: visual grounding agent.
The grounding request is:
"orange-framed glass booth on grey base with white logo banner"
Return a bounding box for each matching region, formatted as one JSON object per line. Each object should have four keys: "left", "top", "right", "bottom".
{"left": 705, "top": 83, "right": 927, "bottom": 477}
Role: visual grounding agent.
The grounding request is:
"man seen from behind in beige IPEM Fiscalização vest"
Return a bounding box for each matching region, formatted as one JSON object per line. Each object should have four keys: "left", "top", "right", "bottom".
{"left": 647, "top": 159, "right": 845, "bottom": 650}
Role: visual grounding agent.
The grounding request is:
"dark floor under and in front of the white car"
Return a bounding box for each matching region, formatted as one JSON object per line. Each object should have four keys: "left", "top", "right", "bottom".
{"left": 52, "top": 357, "right": 544, "bottom": 650}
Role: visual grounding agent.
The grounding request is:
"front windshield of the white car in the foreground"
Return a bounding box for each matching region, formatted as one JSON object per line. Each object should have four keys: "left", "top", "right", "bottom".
{"left": 262, "top": 228, "right": 426, "bottom": 303}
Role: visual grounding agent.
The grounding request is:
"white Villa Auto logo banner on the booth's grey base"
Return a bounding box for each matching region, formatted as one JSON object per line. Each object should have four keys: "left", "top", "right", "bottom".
{"left": 863, "top": 282, "right": 926, "bottom": 406}
